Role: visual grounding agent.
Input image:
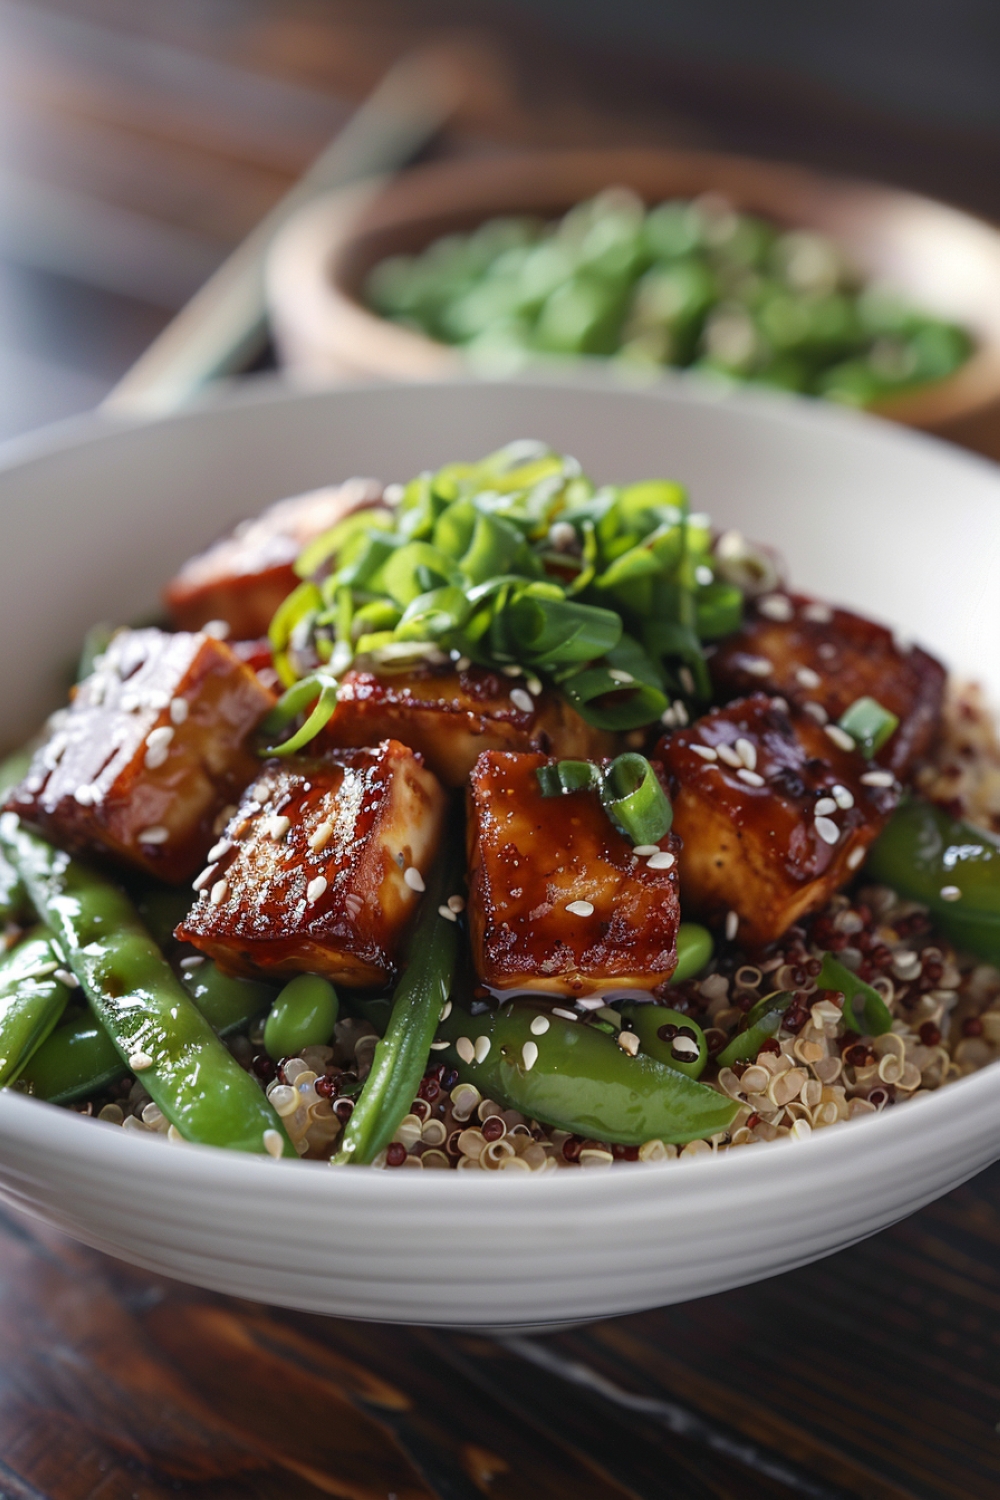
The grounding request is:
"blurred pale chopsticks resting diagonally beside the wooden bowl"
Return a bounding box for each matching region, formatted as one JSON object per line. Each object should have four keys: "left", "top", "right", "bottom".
{"left": 100, "top": 48, "right": 466, "bottom": 417}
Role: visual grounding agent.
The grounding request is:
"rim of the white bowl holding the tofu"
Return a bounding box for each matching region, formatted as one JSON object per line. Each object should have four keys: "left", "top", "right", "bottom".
{"left": 0, "top": 371, "right": 1000, "bottom": 1206}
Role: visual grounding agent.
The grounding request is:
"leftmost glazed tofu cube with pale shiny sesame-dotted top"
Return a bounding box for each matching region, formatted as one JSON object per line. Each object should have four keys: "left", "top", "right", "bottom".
{"left": 6, "top": 630, "right": 274, "bottom": 882}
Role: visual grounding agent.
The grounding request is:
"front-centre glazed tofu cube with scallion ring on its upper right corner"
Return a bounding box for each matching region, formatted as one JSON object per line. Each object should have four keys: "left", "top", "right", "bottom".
{"left": 468, "top": 752, "right": 681, "bottom": 998}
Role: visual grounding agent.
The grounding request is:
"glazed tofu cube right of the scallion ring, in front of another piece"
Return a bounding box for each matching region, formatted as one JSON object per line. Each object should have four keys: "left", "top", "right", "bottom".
{"left": 657, "top": 693, "right": 897, "bottom": 948}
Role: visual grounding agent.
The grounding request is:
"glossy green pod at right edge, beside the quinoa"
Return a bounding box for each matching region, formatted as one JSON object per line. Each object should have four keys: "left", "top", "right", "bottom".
{"left": 865, "top": 798, "right": 1000, "bottom": 965}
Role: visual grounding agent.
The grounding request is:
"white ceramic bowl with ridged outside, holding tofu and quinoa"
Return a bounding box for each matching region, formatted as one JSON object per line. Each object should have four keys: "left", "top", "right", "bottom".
{"left": 0, "top": 380, "right": 1000, "bottom": 1326}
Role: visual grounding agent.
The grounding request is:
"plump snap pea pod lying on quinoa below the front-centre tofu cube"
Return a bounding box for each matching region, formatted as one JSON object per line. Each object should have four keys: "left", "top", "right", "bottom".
{"left": 435, "top": 1002, "right": 738, "bottom": 1146}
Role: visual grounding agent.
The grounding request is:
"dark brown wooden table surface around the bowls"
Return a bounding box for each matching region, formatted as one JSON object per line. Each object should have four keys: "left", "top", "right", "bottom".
{"left": 0, "top": 0, "right": 1000, "bottom": 1500}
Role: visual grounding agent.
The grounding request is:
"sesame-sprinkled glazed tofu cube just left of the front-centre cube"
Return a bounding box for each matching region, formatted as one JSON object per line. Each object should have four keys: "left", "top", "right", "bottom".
{"left": 177, "top": 740, "right": 447, "bottom": 987}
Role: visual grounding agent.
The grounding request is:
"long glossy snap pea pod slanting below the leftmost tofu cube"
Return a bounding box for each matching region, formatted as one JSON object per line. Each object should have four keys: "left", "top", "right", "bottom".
{"left": 0, "top": 813, "right": 297, "bottom": 1157}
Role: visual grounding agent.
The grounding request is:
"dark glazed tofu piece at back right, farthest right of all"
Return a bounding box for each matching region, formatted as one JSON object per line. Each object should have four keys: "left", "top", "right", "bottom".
{"left": 709, "top": 594, "right": 945, "bottom": 776}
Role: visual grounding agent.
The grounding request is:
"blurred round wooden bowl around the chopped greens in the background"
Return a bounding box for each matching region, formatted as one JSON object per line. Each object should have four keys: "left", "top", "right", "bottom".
{"left": 268, "top": 150, "right": 1000, "bottom": 456}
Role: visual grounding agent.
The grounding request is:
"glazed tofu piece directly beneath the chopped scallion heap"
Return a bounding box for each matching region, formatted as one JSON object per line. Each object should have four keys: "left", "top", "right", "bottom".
{"left": 327, "top": 666, "right": 616, "bottom": 786}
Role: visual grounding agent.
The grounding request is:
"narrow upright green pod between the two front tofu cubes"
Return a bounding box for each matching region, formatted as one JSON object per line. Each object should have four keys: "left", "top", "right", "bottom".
{"left": 334, "top": 851, "right": 459, "bottom": 1166}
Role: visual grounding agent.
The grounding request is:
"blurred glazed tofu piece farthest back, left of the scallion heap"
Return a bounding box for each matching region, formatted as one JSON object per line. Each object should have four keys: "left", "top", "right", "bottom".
{"left": 163, "top": 479, "right": 382, "bottom": 641}
